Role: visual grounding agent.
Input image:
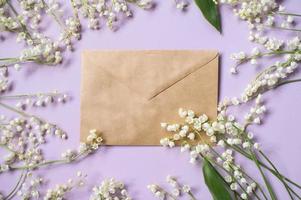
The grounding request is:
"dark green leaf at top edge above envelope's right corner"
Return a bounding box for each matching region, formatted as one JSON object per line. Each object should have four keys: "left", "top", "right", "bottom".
{"left": 195, "top": 0, "right": 221, "bottom": 33}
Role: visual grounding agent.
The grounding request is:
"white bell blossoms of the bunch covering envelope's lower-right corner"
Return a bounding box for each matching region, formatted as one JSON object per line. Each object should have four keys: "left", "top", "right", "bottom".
{"left": 161, "top": 95, "right": 272, "bottom": 199}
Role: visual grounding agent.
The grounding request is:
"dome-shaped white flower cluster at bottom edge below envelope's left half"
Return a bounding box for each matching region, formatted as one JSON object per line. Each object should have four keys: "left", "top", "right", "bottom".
{"left": 90, "top": 178, "right": 131, "bottom": 200}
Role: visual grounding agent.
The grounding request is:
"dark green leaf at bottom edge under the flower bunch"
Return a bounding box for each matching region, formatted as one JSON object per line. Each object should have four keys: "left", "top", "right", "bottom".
{"left": 203, "top": 158, "right": 232, "bottom": 200}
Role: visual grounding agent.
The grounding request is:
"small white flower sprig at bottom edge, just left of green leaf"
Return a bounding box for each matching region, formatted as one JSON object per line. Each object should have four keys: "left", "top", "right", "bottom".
{"left": 147, "top": 175, "right": 196, "bottom": 200}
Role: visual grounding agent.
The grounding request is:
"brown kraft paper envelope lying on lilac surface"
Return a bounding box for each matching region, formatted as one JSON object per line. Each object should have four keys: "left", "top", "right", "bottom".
{"left": 81, "top": 50, "right": 218, "bottom": 145}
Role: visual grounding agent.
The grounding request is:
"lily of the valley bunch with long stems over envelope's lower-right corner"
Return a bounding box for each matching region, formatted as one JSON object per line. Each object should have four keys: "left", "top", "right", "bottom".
{"left": 160, "top": 95, "right": 301, "bottom": 199}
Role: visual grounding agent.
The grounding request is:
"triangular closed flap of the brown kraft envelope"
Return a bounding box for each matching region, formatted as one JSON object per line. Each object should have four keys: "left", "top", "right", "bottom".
{"left": 88, "top": 50, "right": 217, "bottom": 99}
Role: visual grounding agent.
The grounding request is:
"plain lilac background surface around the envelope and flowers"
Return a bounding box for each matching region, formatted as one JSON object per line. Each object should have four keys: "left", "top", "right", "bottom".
{"left": 0, "top": 0, "right": 301, "bottom": 200}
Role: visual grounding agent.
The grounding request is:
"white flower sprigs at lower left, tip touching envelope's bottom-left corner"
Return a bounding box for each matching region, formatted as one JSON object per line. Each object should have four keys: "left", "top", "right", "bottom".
{"left": 0, "top": 109, "right": 103, "bottom": 200}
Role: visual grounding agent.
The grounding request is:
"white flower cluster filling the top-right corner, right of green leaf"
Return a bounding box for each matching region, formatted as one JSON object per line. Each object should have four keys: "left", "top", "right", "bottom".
{"left": 220, "top": 0, "right": 301, "bottom": 102}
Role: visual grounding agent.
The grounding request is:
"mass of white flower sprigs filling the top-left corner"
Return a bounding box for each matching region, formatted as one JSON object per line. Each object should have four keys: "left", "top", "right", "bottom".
{"left": 0, "top": 0, "right": 157, "bottom": 92}
